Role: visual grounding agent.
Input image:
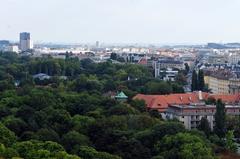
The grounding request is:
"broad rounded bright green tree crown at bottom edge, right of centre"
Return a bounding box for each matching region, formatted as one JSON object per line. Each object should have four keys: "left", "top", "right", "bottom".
{"left": 155, "top": 133, "right": 214, "bottom": 159}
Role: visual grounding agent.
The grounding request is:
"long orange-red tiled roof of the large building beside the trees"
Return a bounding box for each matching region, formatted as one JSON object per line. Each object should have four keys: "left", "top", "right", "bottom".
{"left": 133, "top": 92, "right": 239, "bottom": 112}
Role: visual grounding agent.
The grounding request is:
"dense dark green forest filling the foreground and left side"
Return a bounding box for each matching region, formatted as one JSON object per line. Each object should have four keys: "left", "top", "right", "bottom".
{"left": 0, "top": 52, "right": 240, "bottom": 159}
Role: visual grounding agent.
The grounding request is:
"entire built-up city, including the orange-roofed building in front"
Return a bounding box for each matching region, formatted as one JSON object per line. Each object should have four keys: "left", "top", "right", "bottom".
{"left": 0, "top": 32, "right": 240, "bottom": 132}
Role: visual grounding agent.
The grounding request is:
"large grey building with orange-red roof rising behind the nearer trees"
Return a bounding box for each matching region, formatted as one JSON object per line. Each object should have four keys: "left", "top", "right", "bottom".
{"left": 133, "top": 92, "right": 240, "bottom": 129}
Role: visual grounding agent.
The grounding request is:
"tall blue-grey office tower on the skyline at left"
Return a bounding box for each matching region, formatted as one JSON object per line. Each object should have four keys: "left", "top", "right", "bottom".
{"left": 19, "top": 32, "right": 33, "bottom": 51}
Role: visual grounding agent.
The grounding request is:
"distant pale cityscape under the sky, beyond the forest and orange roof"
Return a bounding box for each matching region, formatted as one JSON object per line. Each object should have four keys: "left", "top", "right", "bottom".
{"left": 0, "top": 32, "right": 240, "bottom": 94}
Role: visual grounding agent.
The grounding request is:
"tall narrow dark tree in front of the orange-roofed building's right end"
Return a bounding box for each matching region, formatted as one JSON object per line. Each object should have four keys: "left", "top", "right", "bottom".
{"left": 214, "top": 99, "right": 226, "bottom": 138}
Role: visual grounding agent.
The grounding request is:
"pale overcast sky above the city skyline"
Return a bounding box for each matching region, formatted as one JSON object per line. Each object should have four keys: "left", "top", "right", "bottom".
{"left": 0, "top": 0, "right": 240, "bottom": 44}
